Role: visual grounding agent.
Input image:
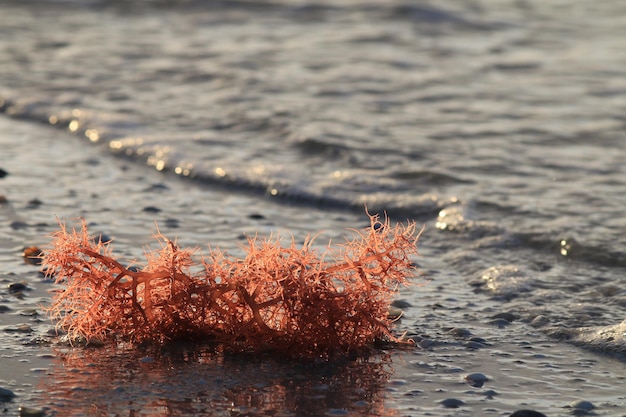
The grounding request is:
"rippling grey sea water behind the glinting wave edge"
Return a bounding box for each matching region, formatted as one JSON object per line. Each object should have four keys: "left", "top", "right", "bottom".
{"left": 0, "top": 0, "right": 626, "bottom": 414}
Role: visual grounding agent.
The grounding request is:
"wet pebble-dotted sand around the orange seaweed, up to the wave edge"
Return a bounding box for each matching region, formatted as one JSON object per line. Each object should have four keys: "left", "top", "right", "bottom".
{"left": 0, "top": 113, "right": 626, "bottom": 416}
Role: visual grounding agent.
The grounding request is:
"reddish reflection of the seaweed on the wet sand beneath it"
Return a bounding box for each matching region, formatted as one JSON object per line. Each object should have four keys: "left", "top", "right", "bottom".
{"left": 40, "top": 345, "right": 395, "bottom": 417}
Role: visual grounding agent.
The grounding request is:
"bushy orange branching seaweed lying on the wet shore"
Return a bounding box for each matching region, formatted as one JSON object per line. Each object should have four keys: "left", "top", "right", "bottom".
{"left": 43, "top": 216, "right": 421, "bottom": 357}
